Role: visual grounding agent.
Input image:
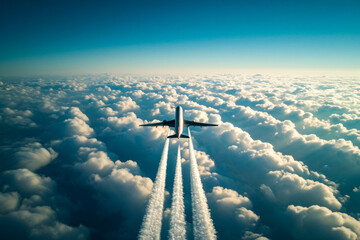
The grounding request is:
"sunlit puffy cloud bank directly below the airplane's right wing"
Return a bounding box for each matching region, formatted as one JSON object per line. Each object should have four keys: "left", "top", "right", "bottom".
{"left": 196, "top": 119, "right": 309, "bottom": 181}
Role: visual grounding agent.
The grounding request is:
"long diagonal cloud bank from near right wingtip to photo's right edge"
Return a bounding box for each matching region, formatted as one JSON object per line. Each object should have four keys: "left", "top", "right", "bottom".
{"left": 219, "top": 103, "right": 360, "bottom": 193}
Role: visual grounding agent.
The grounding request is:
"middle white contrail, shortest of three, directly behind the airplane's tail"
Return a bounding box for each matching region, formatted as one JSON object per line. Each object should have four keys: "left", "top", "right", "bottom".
{"left": 169, "top": 145, "right": 186, "bottom": 240}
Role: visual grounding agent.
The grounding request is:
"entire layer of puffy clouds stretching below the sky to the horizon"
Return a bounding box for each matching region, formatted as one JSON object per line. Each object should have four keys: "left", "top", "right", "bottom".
{"left": 0, "top": 75, "right": 360, "bottom": 240}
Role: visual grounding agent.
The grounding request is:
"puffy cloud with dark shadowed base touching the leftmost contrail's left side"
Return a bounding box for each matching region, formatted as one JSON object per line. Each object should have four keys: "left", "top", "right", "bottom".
{"left": 91, "top": 164, "right": 153, "bottom": 239}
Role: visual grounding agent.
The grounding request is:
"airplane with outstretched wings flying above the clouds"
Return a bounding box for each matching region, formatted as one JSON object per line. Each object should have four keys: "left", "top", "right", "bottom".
{"left": 140, "top": 106, "right": 217, "bottom": 139}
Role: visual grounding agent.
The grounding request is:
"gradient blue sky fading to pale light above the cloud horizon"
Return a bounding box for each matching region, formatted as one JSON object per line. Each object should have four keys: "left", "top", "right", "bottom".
{"left": 0, "top": 0, "right": 360, "bottom": 75}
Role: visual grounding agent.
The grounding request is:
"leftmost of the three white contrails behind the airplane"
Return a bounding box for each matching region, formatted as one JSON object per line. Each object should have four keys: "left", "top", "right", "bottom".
{"left": 139, "top": 138, "right": 169, "bottom": 240}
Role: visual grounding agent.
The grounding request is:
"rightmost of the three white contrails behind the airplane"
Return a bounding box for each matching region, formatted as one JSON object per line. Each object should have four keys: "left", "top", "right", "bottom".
{"left": 188, "top": 129, "right": 216, "bottom": 240}
